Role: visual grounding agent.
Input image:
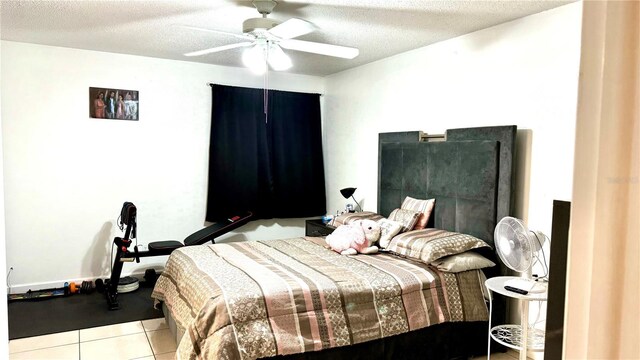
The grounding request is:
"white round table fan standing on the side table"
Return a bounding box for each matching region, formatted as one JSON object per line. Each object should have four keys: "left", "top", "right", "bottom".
{"left": 493, "top": 216, "right": 548, "bottom": 293}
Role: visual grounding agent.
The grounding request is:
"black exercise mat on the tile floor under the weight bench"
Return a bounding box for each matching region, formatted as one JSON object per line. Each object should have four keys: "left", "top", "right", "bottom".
{"left": 8, "top": 287, "right": 163, "bottom": 340}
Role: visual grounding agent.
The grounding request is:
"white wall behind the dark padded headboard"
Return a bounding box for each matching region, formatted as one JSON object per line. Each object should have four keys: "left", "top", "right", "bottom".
{"left": 323, "top": 3, "right": 582, "bottom": 354}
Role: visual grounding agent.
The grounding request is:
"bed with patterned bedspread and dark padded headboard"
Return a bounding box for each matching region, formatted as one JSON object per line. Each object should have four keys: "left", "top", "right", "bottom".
{"left": 152, "top": 126, "right": 516, "bottom": 359}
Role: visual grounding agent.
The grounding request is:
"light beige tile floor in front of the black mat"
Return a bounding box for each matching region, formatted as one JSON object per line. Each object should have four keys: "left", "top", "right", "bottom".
{"left": 9, "top": 318, "right": 176, "bottom": 360}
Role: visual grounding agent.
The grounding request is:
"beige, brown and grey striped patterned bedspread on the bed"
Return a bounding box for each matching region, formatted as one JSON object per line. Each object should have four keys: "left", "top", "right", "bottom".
{"left": 152, "top": 238, "right": 488, "bottom": 359}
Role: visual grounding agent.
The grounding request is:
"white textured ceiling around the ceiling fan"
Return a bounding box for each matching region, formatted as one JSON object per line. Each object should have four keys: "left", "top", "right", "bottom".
{"left": 0, "top": 0, "right": 574, "bottom": 76}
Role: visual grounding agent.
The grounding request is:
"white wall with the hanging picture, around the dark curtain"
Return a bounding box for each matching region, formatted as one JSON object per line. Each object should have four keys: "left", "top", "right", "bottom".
{"left": 1, "top": 41, "right": 324, "bottom": 291}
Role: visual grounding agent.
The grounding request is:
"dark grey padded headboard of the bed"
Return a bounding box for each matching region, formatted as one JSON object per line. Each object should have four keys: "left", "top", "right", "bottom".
{"left": 378, "top": 126, "right": 516, "bottom": 246}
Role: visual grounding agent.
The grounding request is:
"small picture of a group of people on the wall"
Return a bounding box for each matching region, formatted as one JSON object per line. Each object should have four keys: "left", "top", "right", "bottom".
{"left": 89, "top": 87, "right": 140, "bottom": 121}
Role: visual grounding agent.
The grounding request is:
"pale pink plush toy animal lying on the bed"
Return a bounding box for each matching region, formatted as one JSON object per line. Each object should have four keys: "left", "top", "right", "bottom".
{"left": 326, "top": 220, "right": 380, "bottom": 255}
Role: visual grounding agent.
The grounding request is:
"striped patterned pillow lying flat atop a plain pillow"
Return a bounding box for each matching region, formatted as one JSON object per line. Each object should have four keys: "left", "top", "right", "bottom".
{"left": 387, "top": 229, "right": 490, "bottom": 264}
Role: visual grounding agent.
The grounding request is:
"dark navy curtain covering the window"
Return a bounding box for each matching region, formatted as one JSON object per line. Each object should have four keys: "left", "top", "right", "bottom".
{"left": 206, "top": 85, "right": 326, "bottom": 221}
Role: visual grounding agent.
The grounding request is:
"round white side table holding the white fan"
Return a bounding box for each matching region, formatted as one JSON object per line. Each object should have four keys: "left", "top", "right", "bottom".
{"left": 484, "top": 276, "right": 547, "bottom": 360}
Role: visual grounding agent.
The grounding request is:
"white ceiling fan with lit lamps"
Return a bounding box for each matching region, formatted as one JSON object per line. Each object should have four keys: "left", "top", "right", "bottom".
{"left": 182, "top": 0, "right": 359, "bottom": 74}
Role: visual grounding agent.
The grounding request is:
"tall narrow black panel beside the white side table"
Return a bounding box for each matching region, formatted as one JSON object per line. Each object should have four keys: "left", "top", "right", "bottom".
{"left": 544, "top": 200, "right": 571, "bottom": 360}
